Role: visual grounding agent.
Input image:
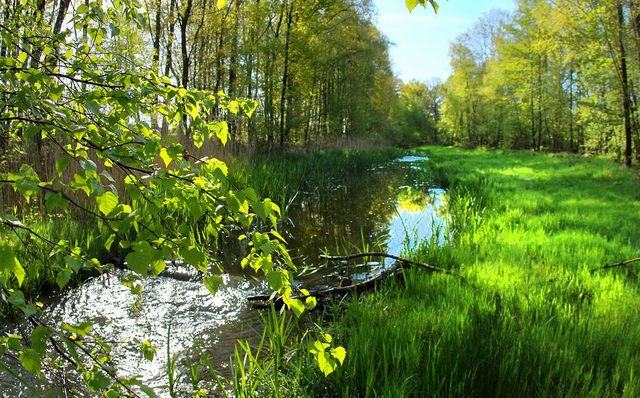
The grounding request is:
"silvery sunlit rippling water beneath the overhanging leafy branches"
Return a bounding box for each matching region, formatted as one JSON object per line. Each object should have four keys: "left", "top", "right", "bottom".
{"left": 48, "top": 271, "right": 265, "bottom": 387}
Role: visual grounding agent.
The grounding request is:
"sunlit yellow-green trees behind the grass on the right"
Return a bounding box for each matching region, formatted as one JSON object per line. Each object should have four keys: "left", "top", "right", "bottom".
{"left": 441, "top": 0, "right": 640, "bottom": 165}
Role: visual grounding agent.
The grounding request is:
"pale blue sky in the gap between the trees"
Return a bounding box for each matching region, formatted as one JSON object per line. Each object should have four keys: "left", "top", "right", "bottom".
{"left": 374, "top": 0, "right": 515, "bottom": 81}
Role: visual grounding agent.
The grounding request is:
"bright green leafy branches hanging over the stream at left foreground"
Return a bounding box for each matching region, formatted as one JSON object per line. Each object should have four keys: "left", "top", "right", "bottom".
{"left": 0, "top": 1, "right": 336, "bottom": 396}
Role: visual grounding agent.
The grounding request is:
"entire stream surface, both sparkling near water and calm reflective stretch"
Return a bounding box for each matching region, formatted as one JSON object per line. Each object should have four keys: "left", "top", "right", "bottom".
{"left": 0, "top": 156, "right": 444, "bottom": 396}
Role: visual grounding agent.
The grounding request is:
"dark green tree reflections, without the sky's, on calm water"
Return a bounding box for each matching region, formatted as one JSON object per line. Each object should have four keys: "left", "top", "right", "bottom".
{"left": 287, "top": 163, "right": 433, "bottom": 260}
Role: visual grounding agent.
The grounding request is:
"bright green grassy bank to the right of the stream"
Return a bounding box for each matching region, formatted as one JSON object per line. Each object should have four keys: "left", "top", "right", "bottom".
{"left": 288, "top": 148, "right": 640, "bottom": 397}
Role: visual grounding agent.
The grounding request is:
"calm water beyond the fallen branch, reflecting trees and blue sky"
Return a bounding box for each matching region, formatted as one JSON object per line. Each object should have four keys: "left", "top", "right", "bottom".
{"left": 287, "top": 156, "right": 444, "bottom": 262}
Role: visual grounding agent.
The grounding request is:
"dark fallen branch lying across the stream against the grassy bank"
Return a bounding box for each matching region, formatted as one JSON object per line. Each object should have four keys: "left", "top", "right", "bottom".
{"left": 247, "top": 252, "right": 457, "bottom": 308}
